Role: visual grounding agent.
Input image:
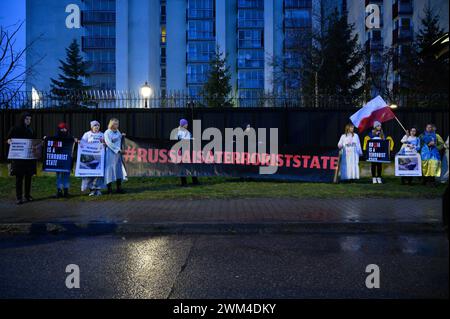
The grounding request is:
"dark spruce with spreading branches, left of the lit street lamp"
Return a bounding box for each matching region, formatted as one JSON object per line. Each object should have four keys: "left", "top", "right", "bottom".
{"left": 51, "top": 40, "right": 90, "bottom": 100}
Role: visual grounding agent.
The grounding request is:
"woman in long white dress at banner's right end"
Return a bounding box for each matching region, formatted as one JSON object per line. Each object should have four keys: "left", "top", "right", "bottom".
{"left": 338, "top": 124, "right": 362, "bottom": 180}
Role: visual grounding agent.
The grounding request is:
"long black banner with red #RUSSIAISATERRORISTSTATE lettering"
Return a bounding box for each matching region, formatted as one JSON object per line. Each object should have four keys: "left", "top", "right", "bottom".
{"left": 123, "top": 139, "right": 338, "bottom": 182}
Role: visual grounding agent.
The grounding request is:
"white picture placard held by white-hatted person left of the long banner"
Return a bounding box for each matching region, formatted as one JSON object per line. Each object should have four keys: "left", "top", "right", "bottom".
{"left": 75, "top": 141, "right": 105, "bottom": 177}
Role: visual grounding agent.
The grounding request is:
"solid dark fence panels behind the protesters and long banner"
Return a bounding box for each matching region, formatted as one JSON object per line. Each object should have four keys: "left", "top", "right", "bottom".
{"left": 0, "top": 106, "right": 449, "bottom": 161}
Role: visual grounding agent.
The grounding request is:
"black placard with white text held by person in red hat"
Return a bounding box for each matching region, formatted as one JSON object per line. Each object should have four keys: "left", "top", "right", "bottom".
{"left": 42, "top": 137, "right": 74, "bottom": 173}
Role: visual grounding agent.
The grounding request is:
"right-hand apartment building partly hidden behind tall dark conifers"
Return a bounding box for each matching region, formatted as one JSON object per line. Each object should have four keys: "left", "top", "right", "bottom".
{"left": 347, "top": 0, "right": 449, "bottom": 96}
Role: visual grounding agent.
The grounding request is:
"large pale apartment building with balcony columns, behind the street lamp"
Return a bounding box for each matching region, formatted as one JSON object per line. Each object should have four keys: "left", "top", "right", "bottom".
{"left": 26, "top": 0, "right": 345, "bottom": 98}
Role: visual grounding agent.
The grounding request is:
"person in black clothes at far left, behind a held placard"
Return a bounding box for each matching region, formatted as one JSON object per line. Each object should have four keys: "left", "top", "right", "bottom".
{"left": 7, "top": 112, "right": 36, "bottom": 205}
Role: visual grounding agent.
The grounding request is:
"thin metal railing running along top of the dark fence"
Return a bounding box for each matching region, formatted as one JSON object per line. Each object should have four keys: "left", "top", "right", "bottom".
{"left": 0, "top": 90, "right": 449, "bottom": 109}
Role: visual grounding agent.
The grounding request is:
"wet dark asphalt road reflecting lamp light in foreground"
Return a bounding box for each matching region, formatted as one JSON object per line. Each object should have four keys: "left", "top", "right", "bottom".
{"left": 0, "top": 234, "right": 449, "bottom": 298}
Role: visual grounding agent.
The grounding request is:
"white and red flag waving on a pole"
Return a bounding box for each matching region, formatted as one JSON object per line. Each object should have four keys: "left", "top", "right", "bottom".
{"left": 350, "top": 95, "right": 395, "bottom": 132}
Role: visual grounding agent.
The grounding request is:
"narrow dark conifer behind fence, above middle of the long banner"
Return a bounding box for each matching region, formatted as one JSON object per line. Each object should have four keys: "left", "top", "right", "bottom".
{"left": 201, "top": 47, "right": 232, "bottom": 107}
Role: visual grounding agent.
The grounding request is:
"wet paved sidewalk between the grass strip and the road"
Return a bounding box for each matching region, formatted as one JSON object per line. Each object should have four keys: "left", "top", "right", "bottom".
{"left": 0, "top": 198, "right": 442, "bottom": 233}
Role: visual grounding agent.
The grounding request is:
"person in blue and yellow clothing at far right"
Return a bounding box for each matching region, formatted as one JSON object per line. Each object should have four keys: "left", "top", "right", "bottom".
{"left": 419, "top": 123, "right": 444, "bottom": 185}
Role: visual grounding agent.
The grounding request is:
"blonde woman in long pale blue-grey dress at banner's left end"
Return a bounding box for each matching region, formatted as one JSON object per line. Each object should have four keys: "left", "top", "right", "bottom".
{"left": 104, "top": 118, "right": 126, "bottom": 194}
